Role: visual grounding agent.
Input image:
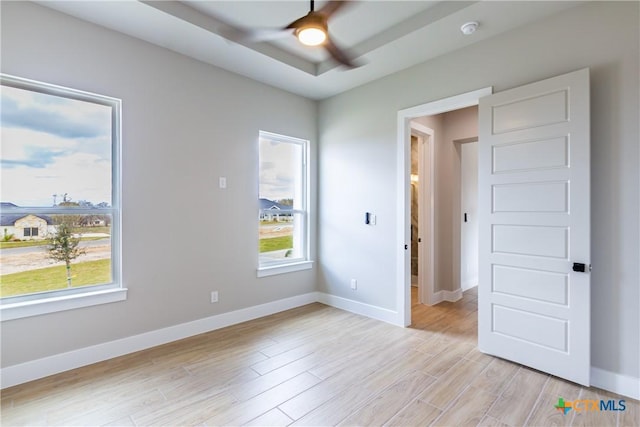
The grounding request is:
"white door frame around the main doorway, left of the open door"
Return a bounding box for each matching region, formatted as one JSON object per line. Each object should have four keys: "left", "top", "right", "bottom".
{"left": 396, "top": 86, "right": 493, "bottom": 326}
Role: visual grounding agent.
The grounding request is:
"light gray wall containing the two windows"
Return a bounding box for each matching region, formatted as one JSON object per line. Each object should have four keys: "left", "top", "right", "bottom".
{"left": 1, "top": 2, "right": 317, "bottom": 366}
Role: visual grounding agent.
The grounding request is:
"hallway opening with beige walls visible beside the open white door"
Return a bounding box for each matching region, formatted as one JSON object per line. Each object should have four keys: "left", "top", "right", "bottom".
{"left": 410, "top": 112, "right": 478, "bottom": 306}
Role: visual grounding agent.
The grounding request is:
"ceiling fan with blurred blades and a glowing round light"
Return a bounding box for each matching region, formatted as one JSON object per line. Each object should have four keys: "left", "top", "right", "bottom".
{"left": 241, "top": 0, "right": 359, "bottom": 68}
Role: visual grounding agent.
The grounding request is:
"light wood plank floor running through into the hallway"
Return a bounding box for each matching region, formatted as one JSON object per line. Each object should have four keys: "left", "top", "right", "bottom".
{"left": 1, "top": 290, "right": 639, "bottom": 426}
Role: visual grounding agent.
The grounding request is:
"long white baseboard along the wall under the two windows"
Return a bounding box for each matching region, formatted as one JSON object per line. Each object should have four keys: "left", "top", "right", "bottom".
{"left": 0, "top": 292, "right": 318, "bottom": 388}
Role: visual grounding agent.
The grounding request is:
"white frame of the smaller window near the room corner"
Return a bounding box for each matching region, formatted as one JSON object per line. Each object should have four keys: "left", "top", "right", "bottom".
{"left": 257, "top": 130, "right": 313, "bottom": 277}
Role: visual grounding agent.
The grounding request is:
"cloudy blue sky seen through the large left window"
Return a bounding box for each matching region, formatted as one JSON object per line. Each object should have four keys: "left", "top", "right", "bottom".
{"left": 0, "top": 86, "right": 111, "bottom": 207}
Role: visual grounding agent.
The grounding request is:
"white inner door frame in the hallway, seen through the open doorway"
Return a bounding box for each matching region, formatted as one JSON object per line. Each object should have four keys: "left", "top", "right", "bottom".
{"left": 409, "top": 122, "right": 435, "bottom": 304}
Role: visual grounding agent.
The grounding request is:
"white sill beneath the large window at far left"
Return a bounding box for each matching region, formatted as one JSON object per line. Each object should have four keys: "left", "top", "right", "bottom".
{"left": 0, "top": 288, "right": 127, "bottom": 322}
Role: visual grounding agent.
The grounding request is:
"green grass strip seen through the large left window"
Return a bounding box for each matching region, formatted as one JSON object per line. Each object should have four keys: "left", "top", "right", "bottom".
{"left": 0, "top": 259, "right": 111, "bottom": 297}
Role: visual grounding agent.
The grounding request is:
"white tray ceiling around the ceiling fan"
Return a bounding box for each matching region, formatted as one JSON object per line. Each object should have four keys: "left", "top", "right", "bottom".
{"left": 38, "top": 0, "right": 580, "bottom": 99}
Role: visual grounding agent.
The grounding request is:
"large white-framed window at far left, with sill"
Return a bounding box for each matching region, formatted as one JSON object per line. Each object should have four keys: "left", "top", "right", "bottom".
{"left": 0, "top": 74, "right": 126, "bottom": 320}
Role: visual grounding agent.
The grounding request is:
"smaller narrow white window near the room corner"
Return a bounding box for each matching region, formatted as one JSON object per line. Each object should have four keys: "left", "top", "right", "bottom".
{"left": 258, "top": 132, "right": 311, "bottom": 276}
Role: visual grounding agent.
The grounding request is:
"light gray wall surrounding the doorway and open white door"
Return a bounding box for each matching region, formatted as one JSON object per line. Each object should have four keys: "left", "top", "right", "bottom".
{"left": 318, "top": 2, "right": 640, "bottom": 378}
